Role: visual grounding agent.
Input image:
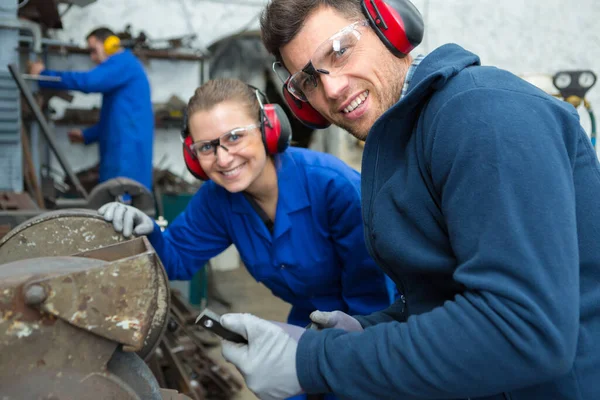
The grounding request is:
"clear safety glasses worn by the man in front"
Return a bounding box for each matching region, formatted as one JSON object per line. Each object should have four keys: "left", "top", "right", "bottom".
{"left": 273, "top": 20, "right": 369, "bottom": 102}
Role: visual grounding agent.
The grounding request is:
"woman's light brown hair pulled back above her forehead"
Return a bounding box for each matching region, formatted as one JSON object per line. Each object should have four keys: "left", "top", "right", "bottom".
{"left": 186, "top": 78, "right": 260, "bottom": 122}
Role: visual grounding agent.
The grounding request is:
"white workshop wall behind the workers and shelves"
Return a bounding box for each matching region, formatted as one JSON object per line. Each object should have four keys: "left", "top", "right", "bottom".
{"left": 50, "top": 0, "right": 600, "bottom": 177}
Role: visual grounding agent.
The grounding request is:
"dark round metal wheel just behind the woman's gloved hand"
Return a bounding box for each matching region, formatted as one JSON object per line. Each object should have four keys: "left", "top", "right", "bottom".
{"left": 87, "top": 177, "right": 156, "bottom": 216}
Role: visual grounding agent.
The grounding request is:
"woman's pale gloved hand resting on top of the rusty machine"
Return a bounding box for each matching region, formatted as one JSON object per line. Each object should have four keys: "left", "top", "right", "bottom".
{"left": 98, "top": 202, "right": 154, "bottom": 237}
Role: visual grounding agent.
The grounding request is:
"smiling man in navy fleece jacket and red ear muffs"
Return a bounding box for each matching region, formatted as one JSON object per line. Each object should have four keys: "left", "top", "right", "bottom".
{"left": 221, "top": 0, "right": 600, "bottom": 400}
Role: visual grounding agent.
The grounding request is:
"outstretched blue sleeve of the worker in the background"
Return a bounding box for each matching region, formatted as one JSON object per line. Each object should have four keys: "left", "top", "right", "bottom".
{"left": 38, "top": 55, "right": 134, "bottom": 93}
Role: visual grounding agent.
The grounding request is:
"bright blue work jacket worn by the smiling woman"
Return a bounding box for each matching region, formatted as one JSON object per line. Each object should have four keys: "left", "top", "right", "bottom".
{"left": 149, "top": 148, "right": 393, "bottom": 326}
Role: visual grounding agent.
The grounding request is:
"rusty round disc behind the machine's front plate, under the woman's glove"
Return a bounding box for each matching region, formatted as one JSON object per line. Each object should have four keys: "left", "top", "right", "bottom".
{"left": 0, "top": 210, "right": 170, "bottom": 359}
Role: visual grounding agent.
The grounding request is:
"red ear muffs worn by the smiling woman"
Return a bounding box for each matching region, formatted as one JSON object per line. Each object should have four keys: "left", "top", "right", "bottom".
{"left": 181, "top": 85, "right": 292, "bottom": 181}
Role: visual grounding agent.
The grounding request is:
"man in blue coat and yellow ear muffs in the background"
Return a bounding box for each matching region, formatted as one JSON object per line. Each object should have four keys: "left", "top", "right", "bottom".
{"left": 30, "top": 28, "right": 154, "bottom": 190}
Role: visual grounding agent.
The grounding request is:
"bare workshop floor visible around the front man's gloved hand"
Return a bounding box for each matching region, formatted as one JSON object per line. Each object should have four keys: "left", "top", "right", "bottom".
{"left": 208, "top": 267, "right": 290, "bottom": 400}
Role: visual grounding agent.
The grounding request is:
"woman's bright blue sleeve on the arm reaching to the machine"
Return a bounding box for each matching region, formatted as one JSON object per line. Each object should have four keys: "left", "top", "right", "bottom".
{"left": 148, "top": 184, "right": 231, "bottom": 280}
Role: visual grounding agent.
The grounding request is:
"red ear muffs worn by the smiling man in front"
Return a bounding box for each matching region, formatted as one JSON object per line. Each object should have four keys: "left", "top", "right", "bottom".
{"left": 283, "top": 0, "right": 425, "bottom": 129}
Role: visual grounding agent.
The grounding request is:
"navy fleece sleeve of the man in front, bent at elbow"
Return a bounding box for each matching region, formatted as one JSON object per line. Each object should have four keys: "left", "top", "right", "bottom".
{"left": 296, "top": 88, "right": 580, "bottom": 400}
